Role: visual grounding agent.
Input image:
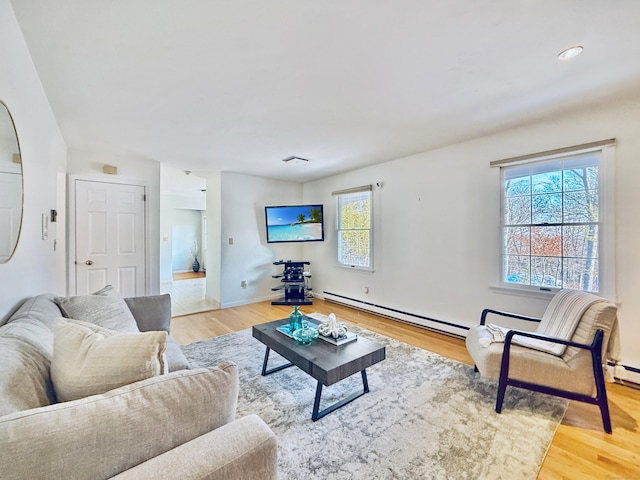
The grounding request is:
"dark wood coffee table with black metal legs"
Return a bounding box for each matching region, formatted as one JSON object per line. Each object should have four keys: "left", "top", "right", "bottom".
{"left": 253, "top": 318, "right": 386, "bottom": 422}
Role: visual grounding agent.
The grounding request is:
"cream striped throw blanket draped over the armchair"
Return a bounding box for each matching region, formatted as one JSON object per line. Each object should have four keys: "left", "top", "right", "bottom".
{"left": 486, "top": 290, "right": 602, "bottom": 356}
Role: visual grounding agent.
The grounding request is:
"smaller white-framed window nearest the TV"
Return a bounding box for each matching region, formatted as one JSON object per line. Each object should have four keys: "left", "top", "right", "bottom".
{"left": 333, "top": 185, "right": 373, "bottom": 270}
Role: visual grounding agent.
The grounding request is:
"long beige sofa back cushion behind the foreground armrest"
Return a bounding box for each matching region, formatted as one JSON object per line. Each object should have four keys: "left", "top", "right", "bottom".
{"left": 0, "top": 363, "right": 238, "bottom": 480}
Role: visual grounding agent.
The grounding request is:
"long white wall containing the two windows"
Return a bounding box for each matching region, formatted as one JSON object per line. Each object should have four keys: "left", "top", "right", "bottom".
{"left": 303, "top": 98, "right": 640, "bottom": 376}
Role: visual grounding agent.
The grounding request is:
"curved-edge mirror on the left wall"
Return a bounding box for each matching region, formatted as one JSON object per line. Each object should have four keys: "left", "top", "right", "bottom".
{"left": 0, "top": 100, "right": 22, "bottom": 263}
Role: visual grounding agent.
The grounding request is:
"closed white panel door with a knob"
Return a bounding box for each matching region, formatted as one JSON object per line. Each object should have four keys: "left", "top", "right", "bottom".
{"left": 75, "top": 180, "right": 146, "bottom": 297}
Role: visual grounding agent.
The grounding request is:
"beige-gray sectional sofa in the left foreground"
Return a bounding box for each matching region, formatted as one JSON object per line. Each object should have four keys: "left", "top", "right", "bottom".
{"left": 0, "top": 294, "right": 277, "bottom": 480}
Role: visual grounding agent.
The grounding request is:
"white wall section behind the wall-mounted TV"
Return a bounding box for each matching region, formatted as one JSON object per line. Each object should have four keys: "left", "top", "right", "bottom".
{"left": 220, "top": 173, "right": 303, "bottom": 307}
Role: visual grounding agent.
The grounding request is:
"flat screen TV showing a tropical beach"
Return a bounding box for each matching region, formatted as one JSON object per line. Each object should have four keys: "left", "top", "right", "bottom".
{"left": 264, "top": 205, "right": 324, "bottom": 243}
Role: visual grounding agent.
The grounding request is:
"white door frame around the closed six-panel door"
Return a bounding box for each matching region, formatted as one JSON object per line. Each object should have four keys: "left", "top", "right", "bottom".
{"left": 67, "top": 174, "right": 150, "bottom": 295}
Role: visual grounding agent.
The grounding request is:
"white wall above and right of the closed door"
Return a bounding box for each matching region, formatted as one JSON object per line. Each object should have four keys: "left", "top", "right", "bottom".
{"left": 67, "top": 149, "right": 160, "bottom": 295}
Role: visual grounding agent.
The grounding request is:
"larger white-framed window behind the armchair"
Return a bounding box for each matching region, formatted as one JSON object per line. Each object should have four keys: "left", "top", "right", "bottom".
{"left": 492, "top": 141, "right": 612, "bottom": 293}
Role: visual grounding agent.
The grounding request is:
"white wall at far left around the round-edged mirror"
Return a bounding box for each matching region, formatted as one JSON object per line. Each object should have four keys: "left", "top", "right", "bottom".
{"left": 0, "top": 0, "right": 66, "bottom": 319}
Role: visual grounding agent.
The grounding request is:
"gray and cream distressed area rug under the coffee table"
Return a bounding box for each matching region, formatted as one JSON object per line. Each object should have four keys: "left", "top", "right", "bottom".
{"left": 182, "top": 327, "right": 567, "bottom": 480}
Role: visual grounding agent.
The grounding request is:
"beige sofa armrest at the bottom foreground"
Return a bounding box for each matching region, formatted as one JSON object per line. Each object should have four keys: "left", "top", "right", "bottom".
{"left": 114, "top": 415, "right": 278, "bottom": 480}
